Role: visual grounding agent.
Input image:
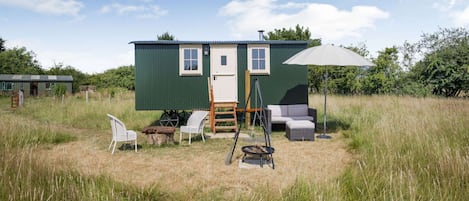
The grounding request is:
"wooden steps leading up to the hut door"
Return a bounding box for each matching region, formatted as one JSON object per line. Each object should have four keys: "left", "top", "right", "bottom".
{"left": 211, "top": 102, "right": 238, "bottom": 134}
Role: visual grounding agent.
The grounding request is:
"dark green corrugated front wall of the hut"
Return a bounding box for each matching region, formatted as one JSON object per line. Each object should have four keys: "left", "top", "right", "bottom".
{"left": 135, "top": 43, "right": 308, "bottom": 110}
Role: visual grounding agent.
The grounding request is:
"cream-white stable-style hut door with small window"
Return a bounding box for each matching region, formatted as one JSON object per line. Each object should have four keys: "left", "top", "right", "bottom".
{"left": 210, "top": 45, "right": 238, "bottom": 102}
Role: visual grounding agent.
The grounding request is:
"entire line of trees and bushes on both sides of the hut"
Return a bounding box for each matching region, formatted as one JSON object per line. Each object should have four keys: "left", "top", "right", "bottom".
{"left": 0, "top": 25, "right": 469, "bottom": 97}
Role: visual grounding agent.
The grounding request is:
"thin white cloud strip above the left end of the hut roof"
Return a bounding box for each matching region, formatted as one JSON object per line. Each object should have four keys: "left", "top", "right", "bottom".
{"left": 100, "top": 3, "right": 168, "bottom": 19}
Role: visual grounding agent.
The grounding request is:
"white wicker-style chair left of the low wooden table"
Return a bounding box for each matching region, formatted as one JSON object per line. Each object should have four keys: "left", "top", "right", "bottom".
{"left": 107, "top": 114, "right": 137, "bottom": 154}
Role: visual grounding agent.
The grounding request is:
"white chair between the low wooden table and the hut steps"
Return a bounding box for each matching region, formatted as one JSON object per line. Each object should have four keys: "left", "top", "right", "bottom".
{"left": 179, "top": 111, "right": 208, "bottom": 144}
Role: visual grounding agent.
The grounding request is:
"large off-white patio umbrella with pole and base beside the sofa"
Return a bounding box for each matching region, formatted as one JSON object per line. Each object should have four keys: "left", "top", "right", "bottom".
{"left": 283, "top": 45, "right": 375, "bottom": 139}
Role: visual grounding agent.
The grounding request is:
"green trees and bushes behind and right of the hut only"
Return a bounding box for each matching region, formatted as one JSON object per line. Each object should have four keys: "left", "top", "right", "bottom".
{"left": 264, "top": 25, "right": 469, "bottom": 97}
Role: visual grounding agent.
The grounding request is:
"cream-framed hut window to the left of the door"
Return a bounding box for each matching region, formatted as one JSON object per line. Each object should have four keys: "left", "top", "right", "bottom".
{"left": 179, "top": 45, "right": 202, "bottom": 76}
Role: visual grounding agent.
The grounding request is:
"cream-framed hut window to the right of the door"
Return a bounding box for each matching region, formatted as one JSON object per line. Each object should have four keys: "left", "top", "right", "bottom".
{"left": 248, "top": 44, "right": 270, "bottom": 75}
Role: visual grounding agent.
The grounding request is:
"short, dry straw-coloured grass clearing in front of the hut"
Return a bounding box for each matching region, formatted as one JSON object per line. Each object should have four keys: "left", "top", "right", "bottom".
{"left": 36, "top": 124, "right": 351, "bottom": 197}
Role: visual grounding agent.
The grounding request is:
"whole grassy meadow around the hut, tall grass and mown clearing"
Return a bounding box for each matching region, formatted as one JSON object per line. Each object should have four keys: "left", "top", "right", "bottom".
{"left": 0, "top": 94, "right": 469, "bottom": 200}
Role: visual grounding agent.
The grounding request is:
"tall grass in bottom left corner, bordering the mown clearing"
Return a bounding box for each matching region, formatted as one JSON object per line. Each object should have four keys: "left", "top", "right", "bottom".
{"left": 0, "top": 147, "right": 171, "bottom": 200}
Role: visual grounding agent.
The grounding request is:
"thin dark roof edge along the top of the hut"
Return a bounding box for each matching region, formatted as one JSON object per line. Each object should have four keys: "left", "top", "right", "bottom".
{"left": 130, "top": 40, "right": 307, "bottom": 45}
